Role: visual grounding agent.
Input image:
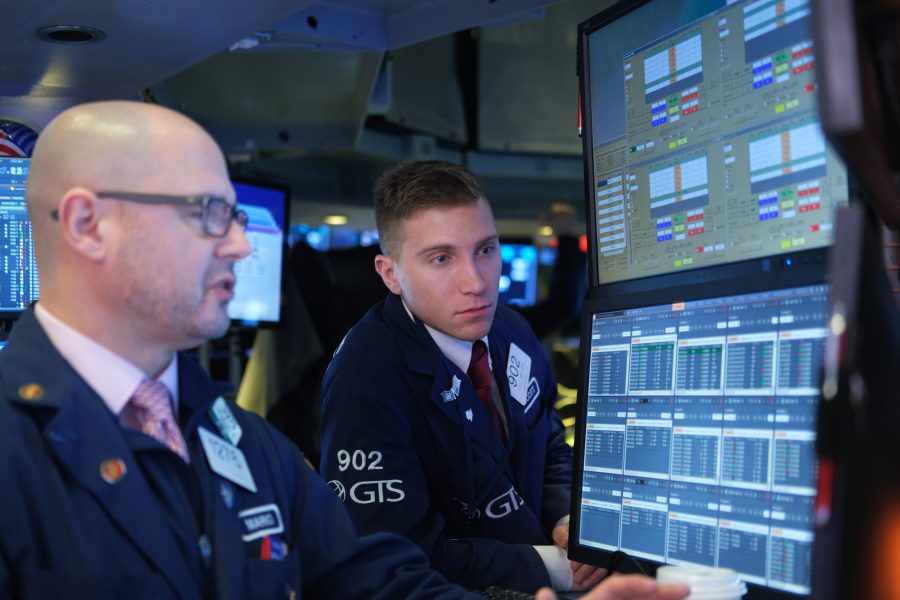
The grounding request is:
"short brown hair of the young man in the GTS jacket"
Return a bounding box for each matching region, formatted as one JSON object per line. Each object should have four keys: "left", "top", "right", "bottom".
{"left": 375, "top": 160, "right": 487, "bottom": 256}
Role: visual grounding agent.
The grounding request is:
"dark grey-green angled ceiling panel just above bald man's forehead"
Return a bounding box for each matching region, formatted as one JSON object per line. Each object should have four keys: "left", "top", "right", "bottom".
{"left": 153, "top": 50, "right": 381, "bottom": 152}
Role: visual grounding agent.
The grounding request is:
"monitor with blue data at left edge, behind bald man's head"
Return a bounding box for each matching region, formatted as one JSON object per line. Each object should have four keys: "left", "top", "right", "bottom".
{"left": 0, "top": 156, "right": 40, "bottom": 319}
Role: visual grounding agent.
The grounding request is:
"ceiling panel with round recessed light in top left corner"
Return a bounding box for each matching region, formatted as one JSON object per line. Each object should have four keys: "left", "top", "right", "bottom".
{"left": 0, "top": 0, "right": 310, "bottom": 98}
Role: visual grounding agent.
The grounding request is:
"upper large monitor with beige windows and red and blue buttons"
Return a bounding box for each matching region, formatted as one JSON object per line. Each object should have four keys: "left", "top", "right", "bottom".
{"left": 578, "top": 0, "right": 848, "bottom": 285}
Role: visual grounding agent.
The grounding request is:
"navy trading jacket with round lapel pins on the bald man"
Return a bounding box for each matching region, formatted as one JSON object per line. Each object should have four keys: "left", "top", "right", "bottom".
{"left": 0, "top": 311, "right": 482, "bottom": 600}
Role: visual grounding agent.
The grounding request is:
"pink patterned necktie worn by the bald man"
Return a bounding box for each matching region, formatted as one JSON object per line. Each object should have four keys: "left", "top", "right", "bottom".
{"left": 123, "top": 379, "right": 191, "bottom": 463}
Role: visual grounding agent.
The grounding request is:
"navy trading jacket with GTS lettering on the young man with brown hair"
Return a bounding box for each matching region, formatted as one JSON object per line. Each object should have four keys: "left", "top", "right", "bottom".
{"left": 321, "top": 294, "right": 572, "bottom": 592}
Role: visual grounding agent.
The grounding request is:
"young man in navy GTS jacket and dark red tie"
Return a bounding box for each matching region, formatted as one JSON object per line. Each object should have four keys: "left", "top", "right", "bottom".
{"left": 322, "top": 161, "right": 604, "bottom": 591}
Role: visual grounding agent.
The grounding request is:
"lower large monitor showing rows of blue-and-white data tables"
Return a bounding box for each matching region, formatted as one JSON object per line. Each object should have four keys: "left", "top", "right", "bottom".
{"left": 569, "top": 280, "right": 828, "bottom": 598}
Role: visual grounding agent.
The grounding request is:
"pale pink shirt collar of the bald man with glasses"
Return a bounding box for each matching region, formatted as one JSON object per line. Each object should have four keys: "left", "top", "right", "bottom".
{"left": 34, "top": 302, "right": 178, "bottom": 414}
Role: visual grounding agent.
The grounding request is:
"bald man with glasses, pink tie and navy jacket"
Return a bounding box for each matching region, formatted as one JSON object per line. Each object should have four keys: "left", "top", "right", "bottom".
{"left": 0, "top": 102, "right": 475, "bottom": 600}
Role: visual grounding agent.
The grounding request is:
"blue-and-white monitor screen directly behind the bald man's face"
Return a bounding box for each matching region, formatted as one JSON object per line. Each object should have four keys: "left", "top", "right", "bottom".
{"left": 228, "top": 179, "right": 290, "bottom": 326}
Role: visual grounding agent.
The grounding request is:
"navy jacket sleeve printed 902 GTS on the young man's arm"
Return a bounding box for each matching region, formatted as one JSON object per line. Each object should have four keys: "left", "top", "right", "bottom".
{"left": 321, "top": 356, "right": 550, "bottom": 593}
